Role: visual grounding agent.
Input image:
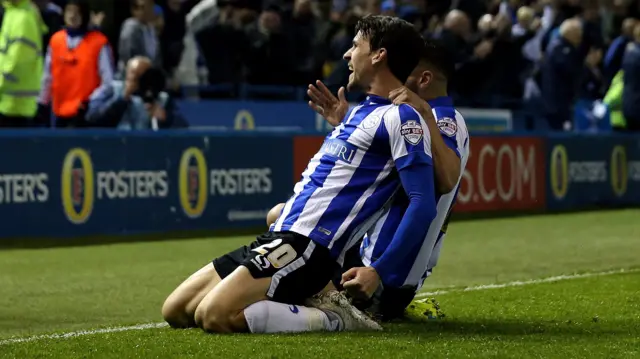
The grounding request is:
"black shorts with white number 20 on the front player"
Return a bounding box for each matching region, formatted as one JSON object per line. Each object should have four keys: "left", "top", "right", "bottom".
{"left": 213, "top": 232, "right": 338, "bottom": 304}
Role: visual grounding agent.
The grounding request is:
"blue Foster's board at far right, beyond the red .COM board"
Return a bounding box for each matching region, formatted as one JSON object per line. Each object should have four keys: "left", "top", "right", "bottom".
{"left": 547, "top": 135, "right": 640, "bottom": 210}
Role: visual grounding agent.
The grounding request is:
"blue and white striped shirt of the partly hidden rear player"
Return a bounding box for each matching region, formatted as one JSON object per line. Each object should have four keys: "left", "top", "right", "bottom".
{"left": 360, "top": 97, "right": 469, "bottom": 288}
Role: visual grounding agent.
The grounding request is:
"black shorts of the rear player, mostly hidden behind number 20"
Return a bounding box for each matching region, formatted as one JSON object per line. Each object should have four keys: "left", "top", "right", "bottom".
{"left": 333, "top": 241, "right": 416, "bottom": 321}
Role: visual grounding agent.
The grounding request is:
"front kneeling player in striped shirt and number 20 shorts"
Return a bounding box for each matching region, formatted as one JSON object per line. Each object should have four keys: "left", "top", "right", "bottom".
{"left": 163, "top": 16, "right": 436, "bottom": 332}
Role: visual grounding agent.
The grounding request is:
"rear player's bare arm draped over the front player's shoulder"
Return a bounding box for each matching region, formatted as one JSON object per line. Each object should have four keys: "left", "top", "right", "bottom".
{"left": 389, "top": 87, "right": 460, "bottom": 194}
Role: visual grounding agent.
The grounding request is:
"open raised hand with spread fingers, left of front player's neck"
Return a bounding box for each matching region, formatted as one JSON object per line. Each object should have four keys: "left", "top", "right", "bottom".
{"left": 307, "top": 80, "right": 349, "bottom": 127}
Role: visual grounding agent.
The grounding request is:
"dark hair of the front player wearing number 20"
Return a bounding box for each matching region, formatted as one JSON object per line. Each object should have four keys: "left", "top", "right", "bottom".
{"left": 356, "top": 15, "right": 424, "bottom": 83}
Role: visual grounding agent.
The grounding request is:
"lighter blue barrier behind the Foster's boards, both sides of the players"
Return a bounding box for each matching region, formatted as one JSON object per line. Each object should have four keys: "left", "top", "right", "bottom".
{"left": 178, "top": 100, "right": 513, "bottom": 134}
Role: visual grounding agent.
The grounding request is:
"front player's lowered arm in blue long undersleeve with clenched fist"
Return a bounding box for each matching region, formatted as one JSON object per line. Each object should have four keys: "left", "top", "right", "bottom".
{"left": 343, "top": 105, "right": 436, "bottom": 297}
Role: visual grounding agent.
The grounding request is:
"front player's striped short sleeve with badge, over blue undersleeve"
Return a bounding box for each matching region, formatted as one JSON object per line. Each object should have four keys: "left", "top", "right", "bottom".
{"left": 384, "top": 104, "right": 433, "bottom": 170}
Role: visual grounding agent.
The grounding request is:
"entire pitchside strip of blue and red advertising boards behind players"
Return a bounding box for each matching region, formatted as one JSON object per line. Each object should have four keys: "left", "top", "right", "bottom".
{"left": 0, "top": 130, "right": 640, "bottom": 238}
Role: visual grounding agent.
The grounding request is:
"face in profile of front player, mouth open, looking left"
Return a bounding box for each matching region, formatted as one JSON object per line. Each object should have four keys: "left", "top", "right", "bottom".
{"left": 344, "top": 32, "right": 373, "bottom": 90}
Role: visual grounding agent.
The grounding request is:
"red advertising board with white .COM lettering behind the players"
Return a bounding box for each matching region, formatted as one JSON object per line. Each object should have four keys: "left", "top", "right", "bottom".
{"left": 293, "top": 136, "right": 546, "bottom": 212}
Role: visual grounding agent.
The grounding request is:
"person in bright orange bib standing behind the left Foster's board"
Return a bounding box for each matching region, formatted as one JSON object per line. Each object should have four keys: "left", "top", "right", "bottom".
{"left": 39, "top": 0, "right": 114, "bottom": 127}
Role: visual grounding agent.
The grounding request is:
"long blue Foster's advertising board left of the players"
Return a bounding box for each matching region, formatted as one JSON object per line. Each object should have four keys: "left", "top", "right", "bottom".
{"left": 0, "top": 132, "right": 293, "bottom": 237}
